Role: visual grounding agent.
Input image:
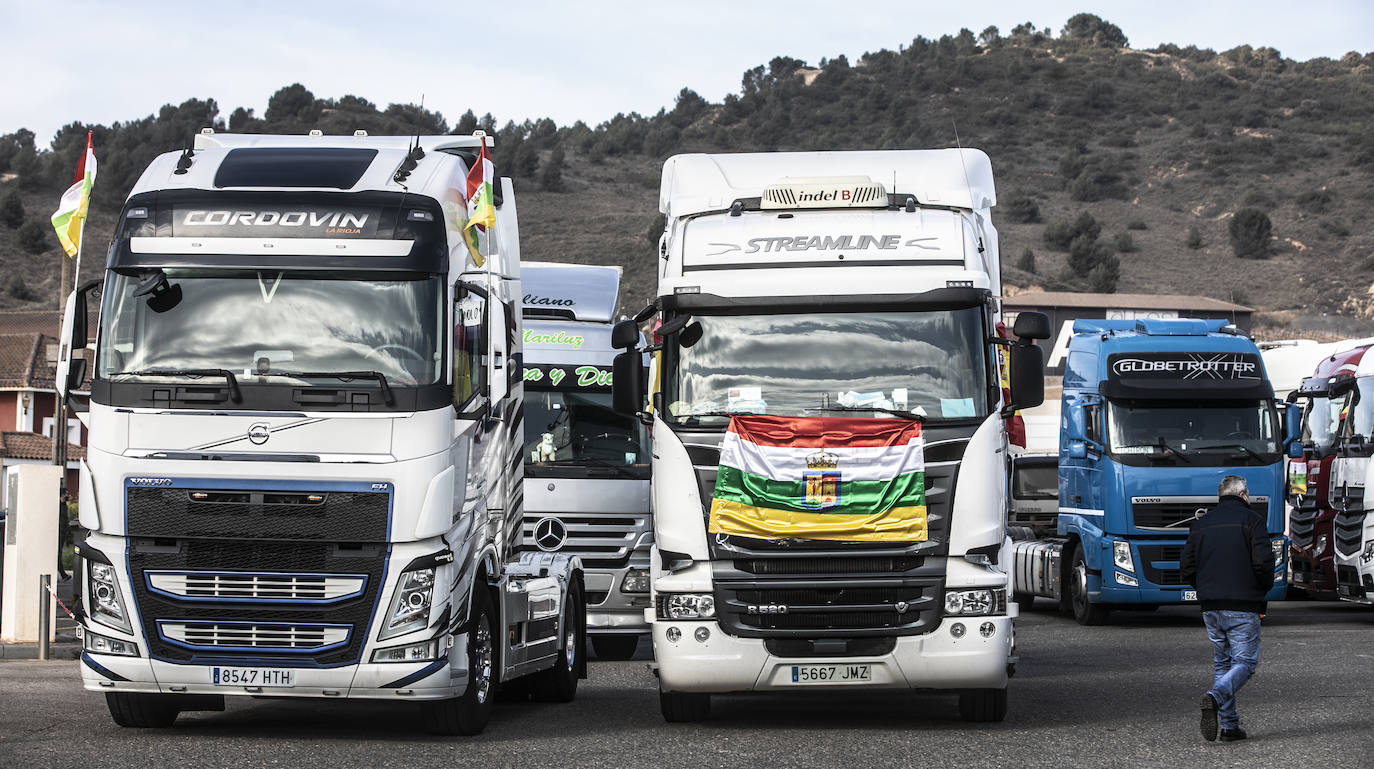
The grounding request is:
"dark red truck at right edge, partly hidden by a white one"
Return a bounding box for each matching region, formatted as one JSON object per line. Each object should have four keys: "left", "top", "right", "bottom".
{"left": 1287, "top": 345, "right": 1369, "bottom": 599}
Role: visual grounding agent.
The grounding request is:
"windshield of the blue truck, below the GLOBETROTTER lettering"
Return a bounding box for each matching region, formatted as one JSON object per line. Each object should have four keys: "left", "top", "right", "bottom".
{"left": 1106, "top": 401, "right": 1279, "bottom": 466}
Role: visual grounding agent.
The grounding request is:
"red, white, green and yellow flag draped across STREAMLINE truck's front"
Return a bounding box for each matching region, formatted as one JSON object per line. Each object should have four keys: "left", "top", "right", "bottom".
{"left": 708, "top": 416, "right": 929, "bottom": 542}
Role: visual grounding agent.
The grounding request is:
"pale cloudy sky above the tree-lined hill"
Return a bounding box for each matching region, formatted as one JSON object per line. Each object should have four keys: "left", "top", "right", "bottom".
{"left": 0, "top": 0, "right": 1374, "bottom": 146}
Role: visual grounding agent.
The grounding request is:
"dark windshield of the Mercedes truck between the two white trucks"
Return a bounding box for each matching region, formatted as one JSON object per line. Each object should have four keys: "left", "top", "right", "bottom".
{"left": 525, "top": 387, "right": 649, "bottom": 478}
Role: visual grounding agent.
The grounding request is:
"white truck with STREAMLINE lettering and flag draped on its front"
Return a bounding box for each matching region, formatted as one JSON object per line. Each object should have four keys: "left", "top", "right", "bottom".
{"left": 613, "top": 150, "right": 1048, "bottom": 721}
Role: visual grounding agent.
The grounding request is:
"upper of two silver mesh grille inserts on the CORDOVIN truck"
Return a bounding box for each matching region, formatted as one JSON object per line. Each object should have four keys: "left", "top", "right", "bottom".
{"left": 144, "top": 571, "right": 367, "bottom": 603}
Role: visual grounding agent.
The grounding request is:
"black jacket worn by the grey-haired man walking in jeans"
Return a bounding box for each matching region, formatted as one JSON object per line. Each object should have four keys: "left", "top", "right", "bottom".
{"left": 1182, "top": 497, "right": 1274, "bottom": 612}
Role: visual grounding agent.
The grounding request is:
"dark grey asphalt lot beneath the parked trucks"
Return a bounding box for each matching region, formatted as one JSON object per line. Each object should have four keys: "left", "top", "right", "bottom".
{"left": 0, "top": 601, "right": 1374, "bottom": 769}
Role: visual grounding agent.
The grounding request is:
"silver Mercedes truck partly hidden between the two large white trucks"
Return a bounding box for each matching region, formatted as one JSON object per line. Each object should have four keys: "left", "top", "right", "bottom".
{"left": 521, "top": 262, "right": 653, "bottom": 659}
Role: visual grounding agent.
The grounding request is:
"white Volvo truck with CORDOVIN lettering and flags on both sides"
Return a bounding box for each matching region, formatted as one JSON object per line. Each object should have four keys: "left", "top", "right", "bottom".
{"left": 58, "top": 130, "right": 584, "bottom": 733}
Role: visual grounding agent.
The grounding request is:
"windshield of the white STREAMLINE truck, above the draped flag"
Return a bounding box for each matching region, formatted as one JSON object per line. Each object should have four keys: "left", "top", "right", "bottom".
{"left": 662, "top": 308, "right": 989, "bottom": 424}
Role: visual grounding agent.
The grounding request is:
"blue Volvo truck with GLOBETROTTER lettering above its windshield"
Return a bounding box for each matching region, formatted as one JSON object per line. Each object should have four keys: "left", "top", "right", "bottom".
{"left": 1011, "top": 319, "right": 1298, "bottom": 625}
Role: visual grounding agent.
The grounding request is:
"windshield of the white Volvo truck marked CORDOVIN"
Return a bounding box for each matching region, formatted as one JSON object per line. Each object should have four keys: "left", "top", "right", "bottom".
{"left": 96, "top": 269, "right": 444, "bottom": 387}
